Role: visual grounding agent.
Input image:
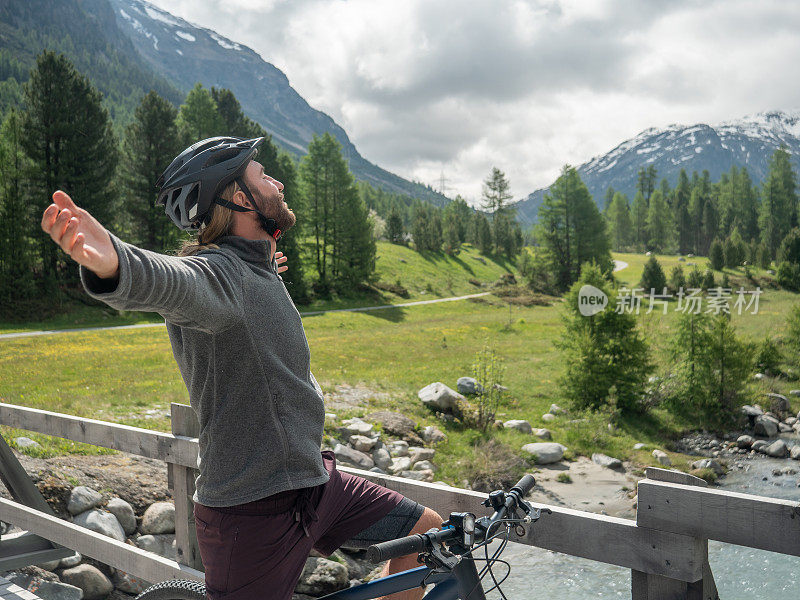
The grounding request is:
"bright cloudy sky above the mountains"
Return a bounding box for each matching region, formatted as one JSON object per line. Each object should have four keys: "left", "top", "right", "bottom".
{"left": 151, "top": 0, "right": 800, "bottom": 202}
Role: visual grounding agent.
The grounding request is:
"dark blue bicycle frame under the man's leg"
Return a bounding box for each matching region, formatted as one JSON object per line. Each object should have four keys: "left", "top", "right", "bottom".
{"left": 318, "top": 555, "right": 486, "bottom": 600}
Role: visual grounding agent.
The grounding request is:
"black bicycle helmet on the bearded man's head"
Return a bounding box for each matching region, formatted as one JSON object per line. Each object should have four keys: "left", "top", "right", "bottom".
{"left": 156, "top": 137, "right": 264, "bottom": 231}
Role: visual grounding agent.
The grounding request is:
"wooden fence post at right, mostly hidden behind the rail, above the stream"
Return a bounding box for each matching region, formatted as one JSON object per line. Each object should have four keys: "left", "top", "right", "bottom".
{"left": 631, "top": 467, "right": 719, "bottom": 600}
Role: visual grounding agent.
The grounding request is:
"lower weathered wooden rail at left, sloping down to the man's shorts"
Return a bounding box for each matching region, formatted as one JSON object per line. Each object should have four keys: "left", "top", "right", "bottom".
{"left": 0, "top": 498, "right": 204, "bottom": 581}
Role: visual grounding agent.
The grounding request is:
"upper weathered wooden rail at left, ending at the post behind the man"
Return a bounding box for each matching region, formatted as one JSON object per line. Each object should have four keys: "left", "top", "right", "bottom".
{"left": 0, "top": 403, "right": 198, "bottom": 468}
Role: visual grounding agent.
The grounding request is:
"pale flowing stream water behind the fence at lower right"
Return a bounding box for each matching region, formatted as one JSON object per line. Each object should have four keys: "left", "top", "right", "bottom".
{"left": 484, "top": 436, "right": 800, "bottom": 600}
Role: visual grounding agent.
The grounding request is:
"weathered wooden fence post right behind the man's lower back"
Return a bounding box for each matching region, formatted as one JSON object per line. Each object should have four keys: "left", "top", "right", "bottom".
{"left": 167, "top": 402, "right": 203, "bottom": 571}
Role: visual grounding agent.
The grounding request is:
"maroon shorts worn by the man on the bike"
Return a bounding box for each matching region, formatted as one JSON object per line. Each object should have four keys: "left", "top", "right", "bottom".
{"left": 194, "top": 452, "right": 422, "bottom": 600}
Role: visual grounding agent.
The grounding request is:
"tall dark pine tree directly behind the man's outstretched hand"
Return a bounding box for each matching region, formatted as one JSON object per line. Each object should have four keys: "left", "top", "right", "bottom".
{"left": 22, "top": 50, "right": 119, "bottom": 281}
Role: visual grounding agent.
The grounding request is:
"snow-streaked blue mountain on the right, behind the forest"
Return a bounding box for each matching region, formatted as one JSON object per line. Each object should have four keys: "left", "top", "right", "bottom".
{"left": 516, "top": 111, "right": 800, "bottom": 224}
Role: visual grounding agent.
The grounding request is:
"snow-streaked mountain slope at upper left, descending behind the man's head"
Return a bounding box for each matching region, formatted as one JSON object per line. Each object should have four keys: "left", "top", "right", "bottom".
{"left": 108, "top": 0, "right": 446, "bottom": 204}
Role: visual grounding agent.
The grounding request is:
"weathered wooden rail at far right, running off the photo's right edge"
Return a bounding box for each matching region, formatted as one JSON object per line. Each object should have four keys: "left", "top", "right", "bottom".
{"left": 636, "top": 480, "right": 800, "bottom": 556}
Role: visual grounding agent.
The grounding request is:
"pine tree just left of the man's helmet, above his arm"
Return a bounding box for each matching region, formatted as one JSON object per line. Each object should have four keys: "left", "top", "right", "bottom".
{"left": 123, "top": 91, "right": 182, "bottom": 252}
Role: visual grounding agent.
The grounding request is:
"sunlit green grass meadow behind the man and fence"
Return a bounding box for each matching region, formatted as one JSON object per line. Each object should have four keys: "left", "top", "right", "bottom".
{"left": 0, "top": 247, "right": 800, "bottom": 483}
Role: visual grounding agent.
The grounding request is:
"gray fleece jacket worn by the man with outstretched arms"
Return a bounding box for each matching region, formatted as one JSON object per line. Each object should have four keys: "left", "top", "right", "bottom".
{"left": 81, "top": 235, "right": 328, "bottom": 506}
